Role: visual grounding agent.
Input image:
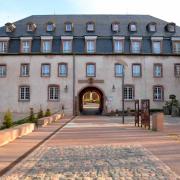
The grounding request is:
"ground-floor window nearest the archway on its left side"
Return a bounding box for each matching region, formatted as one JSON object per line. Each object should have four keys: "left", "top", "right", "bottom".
{"left": 48, "top": 85, "right": 59, "bottom": 101}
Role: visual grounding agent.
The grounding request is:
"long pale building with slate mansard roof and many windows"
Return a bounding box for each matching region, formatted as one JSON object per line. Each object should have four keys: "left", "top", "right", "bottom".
{"left": 0, "top": 15, "right": 180, "bottom": 115}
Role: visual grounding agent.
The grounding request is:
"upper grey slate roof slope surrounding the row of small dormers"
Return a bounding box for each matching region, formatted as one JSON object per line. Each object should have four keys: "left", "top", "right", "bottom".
{"left": 0, "top": 15, "right": 180, "bottom": 37}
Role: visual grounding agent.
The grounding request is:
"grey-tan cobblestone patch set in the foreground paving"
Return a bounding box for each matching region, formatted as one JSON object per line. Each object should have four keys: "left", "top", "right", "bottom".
{"left": 2, "top": 145, "right": 180, "bottom": 180}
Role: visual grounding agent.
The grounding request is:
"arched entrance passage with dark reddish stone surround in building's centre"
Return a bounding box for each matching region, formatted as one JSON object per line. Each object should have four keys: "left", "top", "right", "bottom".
{"left": 79, "top": 87, "right": 104, "bottom": 115}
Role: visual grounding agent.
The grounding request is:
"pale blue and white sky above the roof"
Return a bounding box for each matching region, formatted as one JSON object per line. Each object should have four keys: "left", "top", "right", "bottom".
{"left": 0, "top": 0, "right": 180, "bottom": 26}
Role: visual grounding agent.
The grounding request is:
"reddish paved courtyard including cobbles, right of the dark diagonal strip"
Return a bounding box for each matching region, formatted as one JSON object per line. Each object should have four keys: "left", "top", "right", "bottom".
{"left": 1, "top": 116, "right": 180, "bottom": 180}
